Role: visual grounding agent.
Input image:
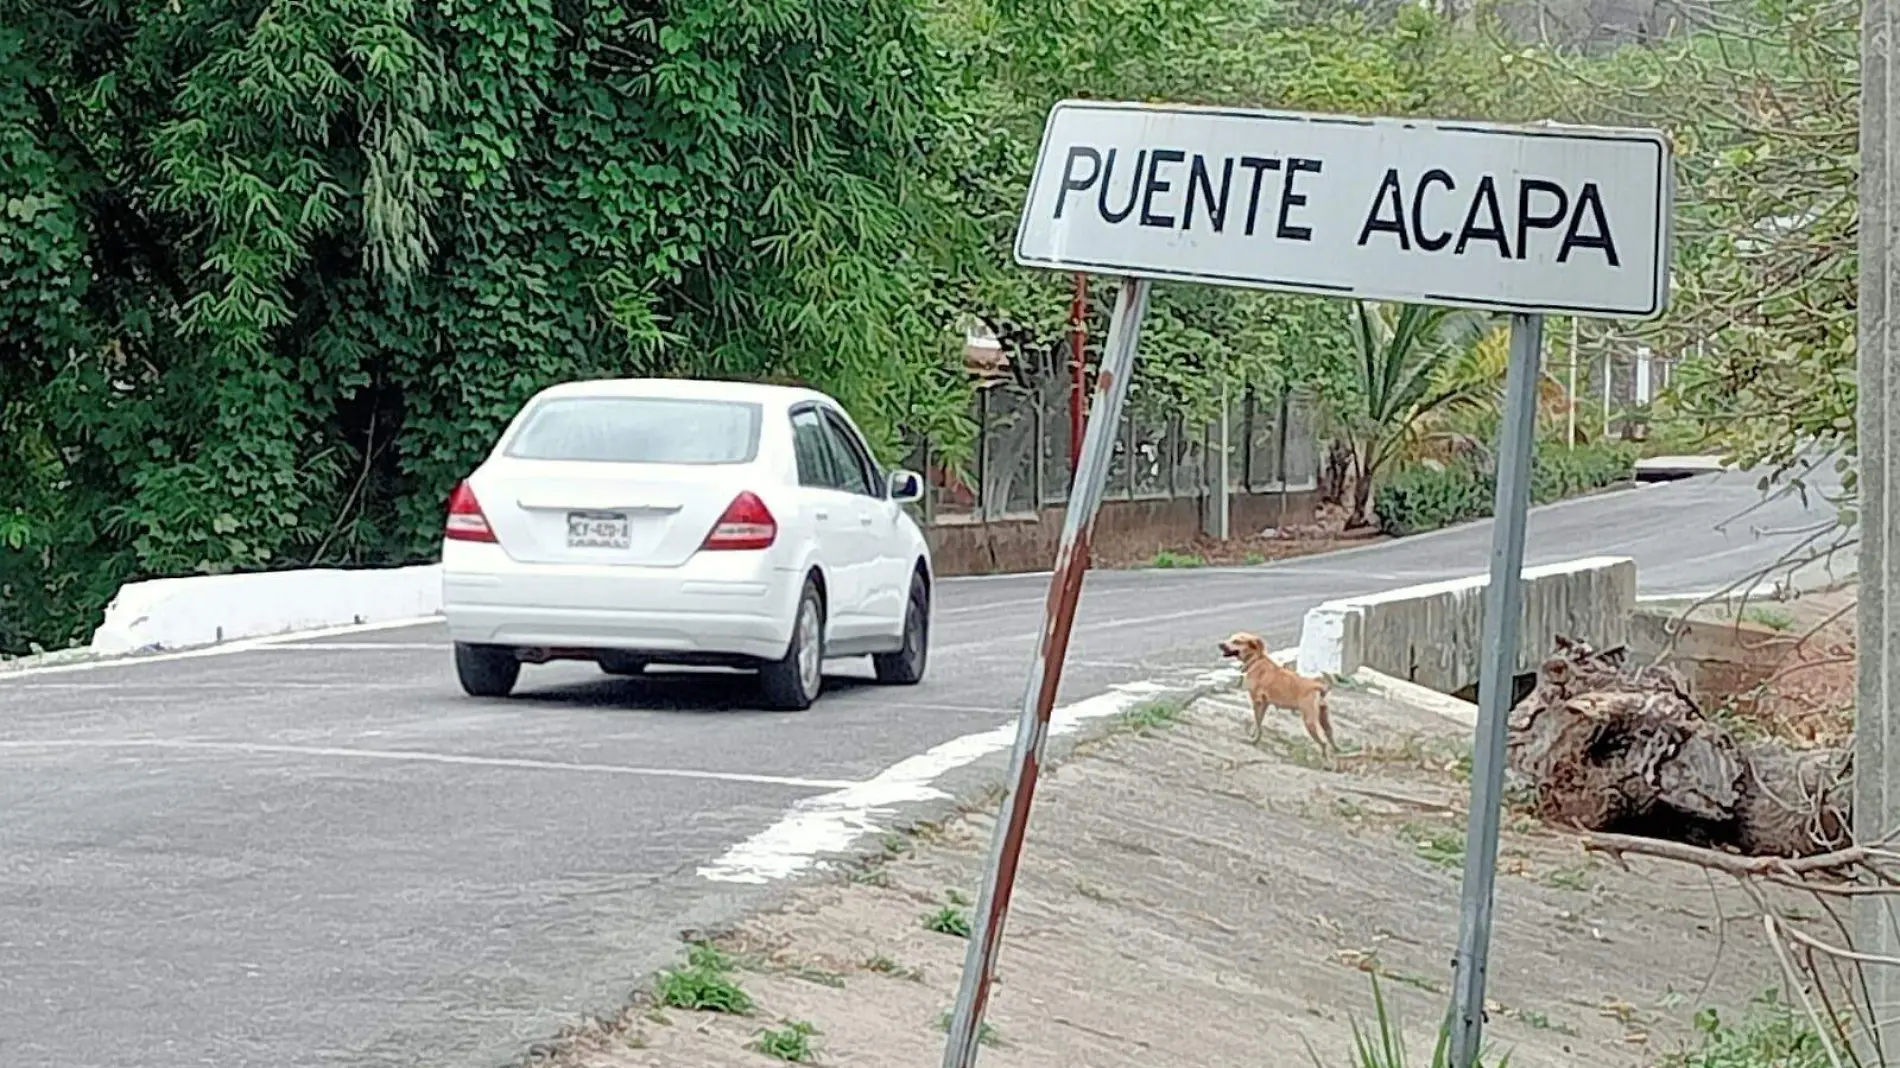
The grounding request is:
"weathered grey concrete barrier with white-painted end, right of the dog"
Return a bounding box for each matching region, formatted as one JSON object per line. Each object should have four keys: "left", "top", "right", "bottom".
{"left": 1300, "top": 557, "right": 1636, "bottom": 694}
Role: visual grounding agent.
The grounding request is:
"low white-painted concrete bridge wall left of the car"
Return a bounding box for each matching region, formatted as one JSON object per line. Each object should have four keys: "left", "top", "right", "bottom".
{"left": 87, "top": 564, "right": 443, "bottom": 656}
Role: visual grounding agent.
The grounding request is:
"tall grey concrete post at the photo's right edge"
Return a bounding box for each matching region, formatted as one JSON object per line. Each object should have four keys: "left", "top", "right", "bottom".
{"left": 1854, "top": 0, "right": 1900, "bottom": 1062}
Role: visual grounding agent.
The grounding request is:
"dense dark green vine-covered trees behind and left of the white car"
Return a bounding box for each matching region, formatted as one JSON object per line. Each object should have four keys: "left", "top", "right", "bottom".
{"left": 0, "top": 0, "right": 972, "bottom": 646}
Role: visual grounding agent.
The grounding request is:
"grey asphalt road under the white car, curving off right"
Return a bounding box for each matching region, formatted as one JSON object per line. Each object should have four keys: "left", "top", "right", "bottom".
{"left": 0, "top": 475, "right": 1839, "bottom": 1068}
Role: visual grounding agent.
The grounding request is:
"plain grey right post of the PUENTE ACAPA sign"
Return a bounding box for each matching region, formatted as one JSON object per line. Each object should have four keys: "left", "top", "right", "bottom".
{"left": 1452, "top": 315, "right": 1543, "bottom": 1068}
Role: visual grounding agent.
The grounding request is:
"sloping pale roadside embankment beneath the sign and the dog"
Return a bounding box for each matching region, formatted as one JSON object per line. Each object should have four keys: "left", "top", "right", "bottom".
{"left": 555, "top": 672, "right": 1771, "bottom": 1068}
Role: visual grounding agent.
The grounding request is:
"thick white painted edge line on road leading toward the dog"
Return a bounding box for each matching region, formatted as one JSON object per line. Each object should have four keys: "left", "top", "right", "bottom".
{"left": 699, "top": 667, "right": 1239, "bottom": 886}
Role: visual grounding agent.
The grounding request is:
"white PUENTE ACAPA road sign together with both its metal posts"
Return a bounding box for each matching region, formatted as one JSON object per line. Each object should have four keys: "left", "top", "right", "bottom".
{"left": 944, "top": 101, "right": 1672, "bottom": 1068}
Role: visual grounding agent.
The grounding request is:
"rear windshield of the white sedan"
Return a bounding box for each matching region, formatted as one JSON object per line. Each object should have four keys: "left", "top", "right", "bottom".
{"left": 507, "top": 397, "right": 760, "bottom": 464}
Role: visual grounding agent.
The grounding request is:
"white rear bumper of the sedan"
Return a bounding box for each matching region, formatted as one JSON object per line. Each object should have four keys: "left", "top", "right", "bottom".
{"left": 443, "top": 542, "right": 800, "bottom": 659}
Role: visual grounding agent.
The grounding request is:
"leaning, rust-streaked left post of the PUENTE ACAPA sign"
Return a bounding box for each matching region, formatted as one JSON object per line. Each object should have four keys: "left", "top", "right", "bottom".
{"left": 944, "top": 277, "right": 1150, "bottom": 1068}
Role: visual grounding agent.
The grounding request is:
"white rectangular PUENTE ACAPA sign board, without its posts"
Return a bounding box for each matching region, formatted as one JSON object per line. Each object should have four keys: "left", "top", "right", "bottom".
{"left": 1017, "top": 101, "right": 1672, "bottom": 319}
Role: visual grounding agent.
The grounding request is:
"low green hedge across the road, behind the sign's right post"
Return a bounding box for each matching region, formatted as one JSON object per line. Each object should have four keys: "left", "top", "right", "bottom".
{"left": 1372, "top": 441, "right": 1636, "bottom": 536}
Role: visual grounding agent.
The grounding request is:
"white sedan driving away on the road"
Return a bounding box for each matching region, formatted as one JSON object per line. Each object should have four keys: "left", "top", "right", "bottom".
{"left": 443, "top": 380, "right": 933, "bottom": 709}
